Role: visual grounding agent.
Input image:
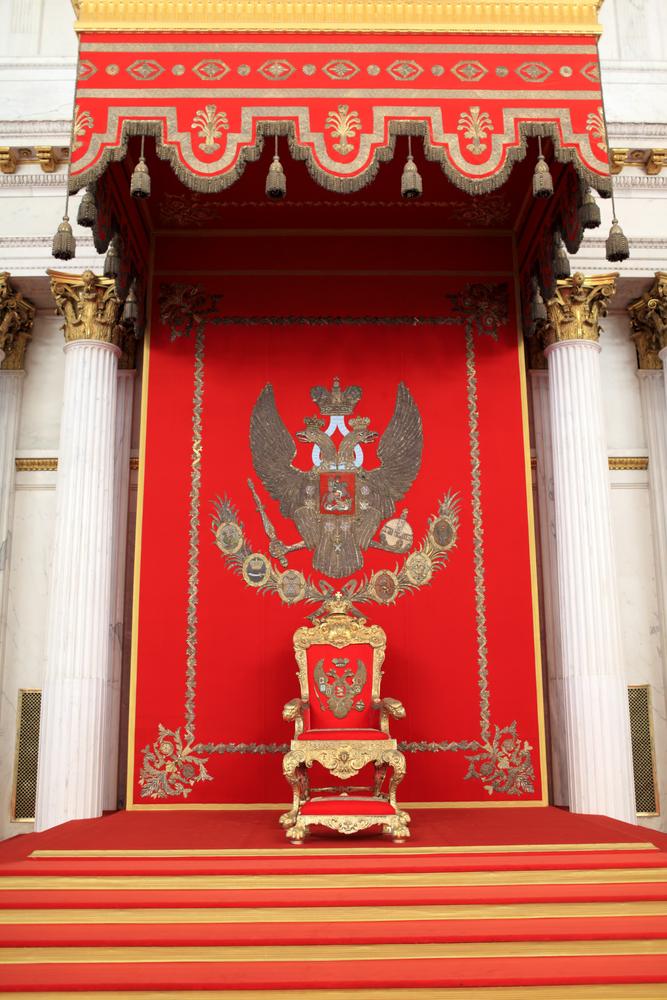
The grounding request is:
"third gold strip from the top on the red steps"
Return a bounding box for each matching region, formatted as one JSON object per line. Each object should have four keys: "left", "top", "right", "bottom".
{"left": 0, "top": 899, "right": 667, "bottom": 926}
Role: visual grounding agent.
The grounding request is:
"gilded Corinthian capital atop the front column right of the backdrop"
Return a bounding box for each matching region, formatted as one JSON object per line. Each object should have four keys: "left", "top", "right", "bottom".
{"left": 544, "top": 272, "right": 618, "bottom": 347}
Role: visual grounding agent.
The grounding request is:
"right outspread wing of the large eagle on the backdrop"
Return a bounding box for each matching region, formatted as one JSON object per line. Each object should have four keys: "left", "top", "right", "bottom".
{"left": 365, "top": 382, "right": 424, "bottom": 518}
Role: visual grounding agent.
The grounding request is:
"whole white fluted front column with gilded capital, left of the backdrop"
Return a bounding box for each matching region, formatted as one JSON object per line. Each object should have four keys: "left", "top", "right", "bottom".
{"left": 35, "top": 271, "right": 120, "bottom": 830}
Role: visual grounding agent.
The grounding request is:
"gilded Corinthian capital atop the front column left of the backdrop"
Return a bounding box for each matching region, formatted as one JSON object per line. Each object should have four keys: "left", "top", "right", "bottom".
{"left": 48, "top": 271, "right": 122, "bottom": 347}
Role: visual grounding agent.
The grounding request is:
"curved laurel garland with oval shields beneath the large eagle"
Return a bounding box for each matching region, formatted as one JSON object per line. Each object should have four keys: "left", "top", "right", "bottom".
{"left": 211, "top": 491, "right": 460, "bottom": 618}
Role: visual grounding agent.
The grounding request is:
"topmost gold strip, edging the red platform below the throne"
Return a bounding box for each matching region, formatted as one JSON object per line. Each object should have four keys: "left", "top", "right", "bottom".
{"left": 29, "top": 841, "right": 658, "bottom": 858}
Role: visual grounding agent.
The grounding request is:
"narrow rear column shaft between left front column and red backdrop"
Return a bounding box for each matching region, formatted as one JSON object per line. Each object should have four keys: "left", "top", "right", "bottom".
{"left": 104, "top": 369, "right": 136, "bottom": 809}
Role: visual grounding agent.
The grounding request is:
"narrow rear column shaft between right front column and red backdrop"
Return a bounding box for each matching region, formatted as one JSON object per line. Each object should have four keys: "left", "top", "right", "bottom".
{"left": 530, "top": 369, "right": 569, "bottom": 806}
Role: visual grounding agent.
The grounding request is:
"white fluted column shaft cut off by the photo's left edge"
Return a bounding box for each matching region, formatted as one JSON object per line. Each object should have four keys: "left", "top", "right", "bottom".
{"left": 0, "top": 370, "right": 25, "bottom": 690}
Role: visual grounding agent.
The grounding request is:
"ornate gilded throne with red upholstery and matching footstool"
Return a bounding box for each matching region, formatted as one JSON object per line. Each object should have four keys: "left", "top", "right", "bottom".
{"left": 280, "top": 599, "right": 410, "bottom": 844}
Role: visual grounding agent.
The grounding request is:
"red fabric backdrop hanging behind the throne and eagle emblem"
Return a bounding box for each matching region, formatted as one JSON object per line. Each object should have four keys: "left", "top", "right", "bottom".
{"left": 129, "top": 230, "right": 544, "bottom": 807}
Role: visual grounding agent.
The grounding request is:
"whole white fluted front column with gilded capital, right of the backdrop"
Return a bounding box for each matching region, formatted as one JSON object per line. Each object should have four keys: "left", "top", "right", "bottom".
{"left": 545, "top": 275, "right": 636, "bottom": 823}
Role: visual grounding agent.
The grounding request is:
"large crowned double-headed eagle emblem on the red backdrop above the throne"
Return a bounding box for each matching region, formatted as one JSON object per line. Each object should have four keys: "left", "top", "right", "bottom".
{"left": 249, "top": 378, "right": 423, "bottom": 578}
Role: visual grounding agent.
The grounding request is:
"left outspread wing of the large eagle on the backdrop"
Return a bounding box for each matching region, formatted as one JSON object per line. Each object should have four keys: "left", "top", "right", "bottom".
{"left": 250, "top": 383, "right": 306, "bottom": 518}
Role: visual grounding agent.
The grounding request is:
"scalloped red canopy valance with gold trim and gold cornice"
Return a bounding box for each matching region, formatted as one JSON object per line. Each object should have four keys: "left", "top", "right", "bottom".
{"left": 71, "top": 0, "right": 609, "bottom": 193}
